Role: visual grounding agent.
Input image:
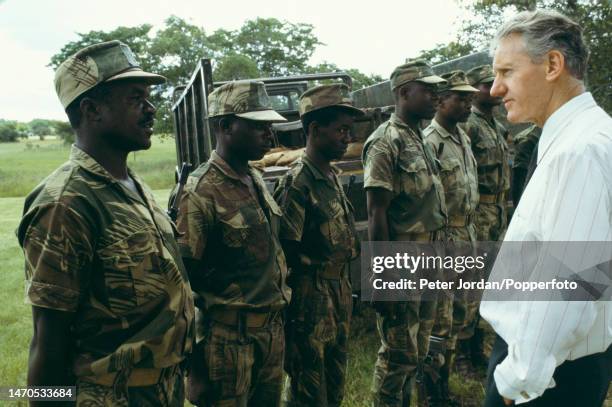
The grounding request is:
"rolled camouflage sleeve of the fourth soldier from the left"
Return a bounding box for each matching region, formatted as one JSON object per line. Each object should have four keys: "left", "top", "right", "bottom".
{"left": 363, "top": 138, "right": 397, "bottom": 192}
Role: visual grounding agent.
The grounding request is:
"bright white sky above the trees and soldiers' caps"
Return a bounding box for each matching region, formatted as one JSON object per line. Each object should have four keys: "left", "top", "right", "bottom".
{"left": 0, "top": 0, "right": 464, "bottom": 121}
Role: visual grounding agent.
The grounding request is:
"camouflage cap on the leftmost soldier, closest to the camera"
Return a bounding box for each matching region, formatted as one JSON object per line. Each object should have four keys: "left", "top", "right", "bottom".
{"left": 54, "top": 41, "right": 166, "bottom": 109}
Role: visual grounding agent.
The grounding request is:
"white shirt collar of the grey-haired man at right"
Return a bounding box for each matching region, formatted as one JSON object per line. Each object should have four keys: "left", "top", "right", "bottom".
{"left": 538, "top": 92, "right": 595, "bottom": 164}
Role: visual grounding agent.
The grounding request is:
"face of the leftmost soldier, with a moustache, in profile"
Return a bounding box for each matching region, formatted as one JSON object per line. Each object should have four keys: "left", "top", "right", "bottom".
{"left": 100, "top": 80, "right": 155, "bottom": 152}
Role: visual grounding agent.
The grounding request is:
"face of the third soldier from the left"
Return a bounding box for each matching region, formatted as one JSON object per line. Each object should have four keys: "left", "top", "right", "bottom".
{"left": 315, "top": 112, "right": 355, "bottom": 161}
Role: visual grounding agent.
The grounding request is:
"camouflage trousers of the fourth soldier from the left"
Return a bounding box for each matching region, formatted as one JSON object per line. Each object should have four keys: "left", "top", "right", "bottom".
{"left": 372, "top": 300, "right": 437, "bottom": 406}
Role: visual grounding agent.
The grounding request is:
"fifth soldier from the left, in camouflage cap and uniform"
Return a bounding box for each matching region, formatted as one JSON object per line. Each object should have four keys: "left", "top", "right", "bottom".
{"left": 423, "top": 71, "right": 478, "bottom": 406}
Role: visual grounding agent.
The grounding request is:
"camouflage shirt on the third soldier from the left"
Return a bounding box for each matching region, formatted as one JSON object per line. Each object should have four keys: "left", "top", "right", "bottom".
{"left": 274, "top": 154, "right": 358, "bottom": 274}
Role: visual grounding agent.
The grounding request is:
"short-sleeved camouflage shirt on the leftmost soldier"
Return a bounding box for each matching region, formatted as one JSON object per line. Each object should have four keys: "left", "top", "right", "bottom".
{"left": 17, "top": 146, "right": 194, "bottom": 377}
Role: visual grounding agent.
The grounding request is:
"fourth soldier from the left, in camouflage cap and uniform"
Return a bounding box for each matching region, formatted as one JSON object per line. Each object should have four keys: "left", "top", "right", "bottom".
{"left": 363, "top": 60, "right": 446, "bottom": 406}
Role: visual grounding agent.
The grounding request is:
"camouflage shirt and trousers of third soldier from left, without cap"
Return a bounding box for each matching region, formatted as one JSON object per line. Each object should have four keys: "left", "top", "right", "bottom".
{"left": 275, "top": 155, "right": 358, "bottom": 406}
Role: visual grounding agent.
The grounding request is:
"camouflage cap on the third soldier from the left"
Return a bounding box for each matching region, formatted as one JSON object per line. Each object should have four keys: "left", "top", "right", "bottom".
{"left": 299, "top": 83, "right": 364, "bottom": 117}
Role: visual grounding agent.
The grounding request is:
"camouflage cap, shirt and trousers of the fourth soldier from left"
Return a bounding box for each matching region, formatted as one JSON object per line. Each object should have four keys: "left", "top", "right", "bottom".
{"left": 362, "top": 61, "right": 446, "bottom": 405}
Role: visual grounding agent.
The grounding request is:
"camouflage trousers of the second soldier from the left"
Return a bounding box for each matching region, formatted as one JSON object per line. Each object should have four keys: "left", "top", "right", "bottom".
{"left": 187, "top": 313, "right": 285, "bottom": 407}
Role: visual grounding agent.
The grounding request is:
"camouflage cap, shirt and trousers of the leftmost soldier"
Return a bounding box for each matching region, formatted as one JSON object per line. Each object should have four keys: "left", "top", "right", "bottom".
{"left": 17, "top": 41, "right": 194, "bottom": 406}
